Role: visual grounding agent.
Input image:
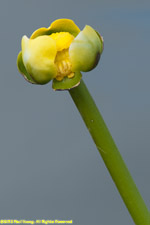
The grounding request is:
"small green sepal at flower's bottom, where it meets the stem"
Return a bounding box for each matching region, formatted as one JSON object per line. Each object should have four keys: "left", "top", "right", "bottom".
{"left": 52, "top": 72, "right": 82, "bottom": 91}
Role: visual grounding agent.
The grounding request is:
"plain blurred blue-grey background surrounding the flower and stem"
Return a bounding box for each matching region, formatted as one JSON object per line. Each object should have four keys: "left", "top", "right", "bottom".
{"left": 0, "top": 0, "right": 150, "bottom": 225}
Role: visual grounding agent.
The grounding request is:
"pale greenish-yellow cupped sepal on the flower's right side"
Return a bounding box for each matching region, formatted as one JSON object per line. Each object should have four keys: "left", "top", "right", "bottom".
{"left": 69, "top": 25, "right": 103, "bottom": 72}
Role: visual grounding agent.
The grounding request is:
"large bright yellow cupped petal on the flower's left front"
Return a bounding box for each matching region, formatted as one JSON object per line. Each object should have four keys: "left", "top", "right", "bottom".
{"left": 22, "top": 35, "right": 57, "bottom": 84}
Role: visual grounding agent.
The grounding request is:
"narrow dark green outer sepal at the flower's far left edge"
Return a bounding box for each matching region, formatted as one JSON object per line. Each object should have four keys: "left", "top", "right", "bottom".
{"left": 17, "top": 52, "right": 38, "bottom": 84}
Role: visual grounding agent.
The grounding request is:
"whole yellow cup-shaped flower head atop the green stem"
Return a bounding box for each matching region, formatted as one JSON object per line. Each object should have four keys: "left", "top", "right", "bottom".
{"left": 17, "top": 19, "right": 103, "bottom": 90}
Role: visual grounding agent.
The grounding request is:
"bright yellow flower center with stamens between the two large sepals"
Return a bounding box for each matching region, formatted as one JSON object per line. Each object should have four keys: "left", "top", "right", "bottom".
{"left": 50, "top": 32, "right": 74, "bottom": 81}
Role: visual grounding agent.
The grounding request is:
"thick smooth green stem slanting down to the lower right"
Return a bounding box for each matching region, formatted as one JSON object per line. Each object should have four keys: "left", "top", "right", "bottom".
{"left": 69, "top": 80, "right": 150, "bottom": 225}
